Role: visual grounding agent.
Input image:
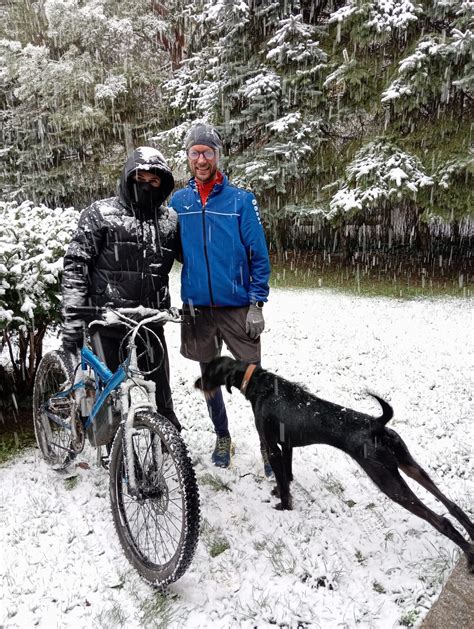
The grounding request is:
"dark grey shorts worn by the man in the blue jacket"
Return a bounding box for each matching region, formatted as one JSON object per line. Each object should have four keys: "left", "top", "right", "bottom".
{"left": 181, "top": 306, "right": 260, "bottom": 363}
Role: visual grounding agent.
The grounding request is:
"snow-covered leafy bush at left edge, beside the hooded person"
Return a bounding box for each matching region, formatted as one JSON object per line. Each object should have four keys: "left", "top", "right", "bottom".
{"left": 0, "top": 201, "right": 79, "bottom": 389}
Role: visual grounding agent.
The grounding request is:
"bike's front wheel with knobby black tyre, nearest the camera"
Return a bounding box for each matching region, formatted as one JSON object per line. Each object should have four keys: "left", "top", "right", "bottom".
{"left": 109, "top": 411, "right": 200, "bottom": 586}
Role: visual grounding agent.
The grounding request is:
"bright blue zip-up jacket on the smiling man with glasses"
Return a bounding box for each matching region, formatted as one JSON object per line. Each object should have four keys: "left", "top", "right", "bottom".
{"left": 169, "top": 175, "right": 270, "bottom": 306}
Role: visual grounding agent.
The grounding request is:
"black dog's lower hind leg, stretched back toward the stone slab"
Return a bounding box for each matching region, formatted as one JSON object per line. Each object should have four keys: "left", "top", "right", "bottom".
{"left": 357, "top": 459, "right": 474, "bottom": 572}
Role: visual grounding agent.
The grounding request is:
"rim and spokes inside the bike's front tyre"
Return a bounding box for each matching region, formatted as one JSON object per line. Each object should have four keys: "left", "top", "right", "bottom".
{"left": 116, "top": 426, "right": 184, "bottom": 569}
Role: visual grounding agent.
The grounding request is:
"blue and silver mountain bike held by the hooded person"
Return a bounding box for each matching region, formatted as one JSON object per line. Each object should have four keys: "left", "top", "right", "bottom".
{"left": 33, "top": 307, "right": 200, "bottom": 586}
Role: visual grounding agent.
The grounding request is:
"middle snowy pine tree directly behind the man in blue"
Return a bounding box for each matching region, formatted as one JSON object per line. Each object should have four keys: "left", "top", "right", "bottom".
{"left": 158, "top": 0, "right": 327, "bottom": 251}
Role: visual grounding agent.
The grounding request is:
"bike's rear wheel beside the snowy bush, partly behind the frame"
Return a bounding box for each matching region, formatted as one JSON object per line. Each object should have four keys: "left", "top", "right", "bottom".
{"left": 33, "top": 351, "right": 77, "bottom": 469}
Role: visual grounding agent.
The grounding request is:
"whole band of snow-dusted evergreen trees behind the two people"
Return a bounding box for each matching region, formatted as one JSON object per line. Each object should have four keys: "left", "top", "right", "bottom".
{"left": 0, "top": 0, "right": 474, "bottom": 238}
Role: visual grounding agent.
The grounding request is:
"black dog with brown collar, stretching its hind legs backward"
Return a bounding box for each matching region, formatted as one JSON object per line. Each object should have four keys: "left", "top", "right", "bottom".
{"left": 195, "top": 357, "right": 474, "bottom": 572}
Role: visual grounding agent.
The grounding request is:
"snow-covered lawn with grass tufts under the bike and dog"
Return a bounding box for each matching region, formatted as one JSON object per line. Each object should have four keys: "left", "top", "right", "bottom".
{"left": 0, "top": 275, "right": 474, "bottom": 629}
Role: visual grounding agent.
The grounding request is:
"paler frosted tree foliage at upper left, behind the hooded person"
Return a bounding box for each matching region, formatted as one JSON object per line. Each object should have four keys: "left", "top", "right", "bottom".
{"left": 0, "top": 0, "right": 169, "bottom": 205}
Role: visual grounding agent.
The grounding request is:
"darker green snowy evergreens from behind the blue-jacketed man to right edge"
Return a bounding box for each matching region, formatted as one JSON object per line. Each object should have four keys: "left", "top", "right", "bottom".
{"left": 157, "top": 0, "right": 473, "bottom": 251}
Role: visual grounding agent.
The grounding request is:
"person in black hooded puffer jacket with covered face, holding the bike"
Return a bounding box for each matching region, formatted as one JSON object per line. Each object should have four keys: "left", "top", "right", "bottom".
{"left": 62, "top": 147, "right": 180, "bottom": 428}
